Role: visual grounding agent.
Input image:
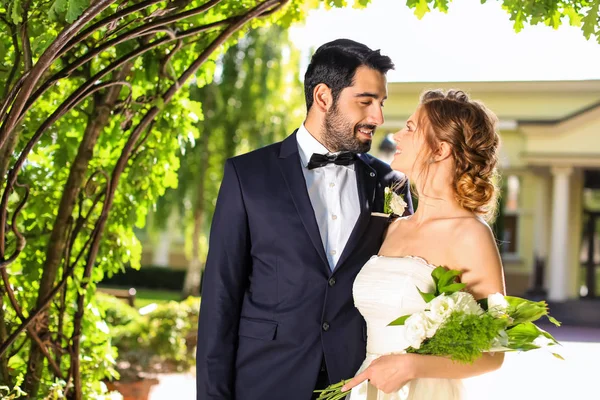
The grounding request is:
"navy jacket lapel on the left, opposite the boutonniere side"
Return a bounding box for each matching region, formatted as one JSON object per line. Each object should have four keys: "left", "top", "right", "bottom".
{"left": 279, "top": 132, "right": 329, "bottom": 272}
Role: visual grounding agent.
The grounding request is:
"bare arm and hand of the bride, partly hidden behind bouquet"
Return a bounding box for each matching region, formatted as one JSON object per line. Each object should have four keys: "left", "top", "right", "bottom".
{"left": 344, "top": 219, "right": 505, "bottom": 393}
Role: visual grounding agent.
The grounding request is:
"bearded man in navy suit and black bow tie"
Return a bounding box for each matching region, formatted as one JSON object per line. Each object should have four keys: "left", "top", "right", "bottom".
{"left": 196, "top": 39, "right": 412, "bottom": 400}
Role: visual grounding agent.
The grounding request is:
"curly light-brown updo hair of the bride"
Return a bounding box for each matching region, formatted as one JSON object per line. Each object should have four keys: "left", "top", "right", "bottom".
{"left": 418, "top": 90, "right": 500, "bottom": 221}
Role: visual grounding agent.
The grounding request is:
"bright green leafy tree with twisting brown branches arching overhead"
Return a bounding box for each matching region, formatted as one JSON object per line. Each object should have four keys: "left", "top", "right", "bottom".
{"left": 0, "top": 0, "right": 598, "bottom": 400}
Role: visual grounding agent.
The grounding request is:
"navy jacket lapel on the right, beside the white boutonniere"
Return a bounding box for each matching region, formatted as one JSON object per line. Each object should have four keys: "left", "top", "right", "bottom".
{"left": 334, "top": 154, "right": 377, "bottom": 271}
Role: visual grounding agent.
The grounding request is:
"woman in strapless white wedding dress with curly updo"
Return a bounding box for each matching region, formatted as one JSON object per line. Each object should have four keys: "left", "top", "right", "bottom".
{"left": 343, "top": 91, "right": 504, "bottom": 400}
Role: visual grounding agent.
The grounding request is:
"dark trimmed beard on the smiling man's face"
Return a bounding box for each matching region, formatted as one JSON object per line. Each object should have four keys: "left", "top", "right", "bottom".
{"left": 323, "top": 106, "right": 376, "bottom": 153}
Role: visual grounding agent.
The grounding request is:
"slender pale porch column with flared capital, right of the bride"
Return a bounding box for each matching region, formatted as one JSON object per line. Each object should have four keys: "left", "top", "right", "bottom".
{"left": 548, "top": 167, "right": 573, "bottom": 301}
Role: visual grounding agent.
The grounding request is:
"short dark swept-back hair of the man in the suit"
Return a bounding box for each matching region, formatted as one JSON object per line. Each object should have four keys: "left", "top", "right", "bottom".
{"left": 304, "top": 39, "right": 394, "bottom": 110}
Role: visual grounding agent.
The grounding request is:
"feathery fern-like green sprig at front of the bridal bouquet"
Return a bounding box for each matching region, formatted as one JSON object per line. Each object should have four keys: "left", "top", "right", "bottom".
{"left": 407, "top": 311, "right": 504, "bottom": 363}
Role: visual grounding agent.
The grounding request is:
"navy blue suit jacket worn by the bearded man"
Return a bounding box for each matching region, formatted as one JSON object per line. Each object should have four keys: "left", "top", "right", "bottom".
{"left": 196, "top": 133, "right": 412, "bottom": 400}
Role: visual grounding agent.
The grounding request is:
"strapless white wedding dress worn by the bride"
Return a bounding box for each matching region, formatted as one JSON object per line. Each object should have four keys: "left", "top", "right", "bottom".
{"left": 346, "top": 256, "right": 463, "bottom": 400}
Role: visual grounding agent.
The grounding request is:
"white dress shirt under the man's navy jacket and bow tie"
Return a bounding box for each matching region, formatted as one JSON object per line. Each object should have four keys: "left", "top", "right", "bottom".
{"left": 296, "top": 124, "right": 360, "bottom": 270}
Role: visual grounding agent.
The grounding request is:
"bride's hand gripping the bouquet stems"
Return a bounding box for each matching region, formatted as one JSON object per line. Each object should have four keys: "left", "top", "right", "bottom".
{"left": 342, "top": 354, "right": 414, "bottom": 393}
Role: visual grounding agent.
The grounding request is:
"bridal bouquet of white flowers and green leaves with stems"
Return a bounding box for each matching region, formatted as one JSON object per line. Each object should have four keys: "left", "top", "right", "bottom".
{"left": 317, "top": 267, "right": 562, "bottom": 400}
